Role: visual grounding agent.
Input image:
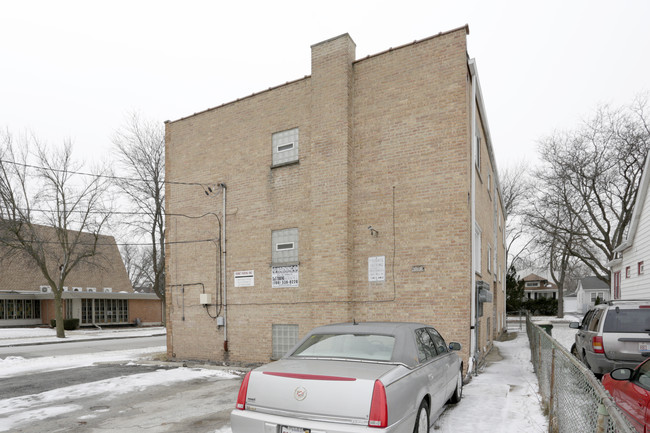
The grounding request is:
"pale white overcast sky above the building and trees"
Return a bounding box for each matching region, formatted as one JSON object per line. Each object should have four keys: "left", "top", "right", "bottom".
{"left": 0, "top": 0, "right": 650, "bottom": 174}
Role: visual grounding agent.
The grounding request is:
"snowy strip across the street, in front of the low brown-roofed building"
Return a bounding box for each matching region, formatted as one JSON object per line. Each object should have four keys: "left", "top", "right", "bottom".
{"left": 0, "top": 326, "right": 167, "bottom": 347}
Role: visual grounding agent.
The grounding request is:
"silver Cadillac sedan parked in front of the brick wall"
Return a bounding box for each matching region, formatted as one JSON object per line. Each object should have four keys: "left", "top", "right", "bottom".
{"left": 230, "top": 322, "right": 463, "bottom": 433}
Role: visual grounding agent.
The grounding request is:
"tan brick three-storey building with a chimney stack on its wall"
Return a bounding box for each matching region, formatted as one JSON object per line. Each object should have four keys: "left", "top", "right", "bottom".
{"left": 165, "top": 27, "right": 505, "bottom": 369}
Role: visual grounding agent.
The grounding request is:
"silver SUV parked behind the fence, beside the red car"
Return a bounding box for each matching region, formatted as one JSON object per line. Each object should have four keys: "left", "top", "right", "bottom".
{"left": 569, "top": 300, "right": 650, "bottom": 374}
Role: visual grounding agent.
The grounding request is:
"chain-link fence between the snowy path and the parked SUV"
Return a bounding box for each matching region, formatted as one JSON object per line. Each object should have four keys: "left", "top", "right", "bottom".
{"left": 526, "top": 317, "right": 636, "bottom": 433}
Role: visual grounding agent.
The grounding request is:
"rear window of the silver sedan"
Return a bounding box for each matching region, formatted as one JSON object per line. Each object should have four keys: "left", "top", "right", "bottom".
{"left": 291, "top": 334, "right": 395, "bottom": 361}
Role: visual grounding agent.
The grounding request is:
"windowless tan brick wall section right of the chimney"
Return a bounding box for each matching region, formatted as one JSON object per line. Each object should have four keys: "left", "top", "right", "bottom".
{"left": 351, "top": 31, "right": 471, "bottom": 356}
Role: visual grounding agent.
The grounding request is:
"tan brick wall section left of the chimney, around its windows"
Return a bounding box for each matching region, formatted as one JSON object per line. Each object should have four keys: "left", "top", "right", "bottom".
{"left": 166, "top": 79, "right": 316, "bottom": 361}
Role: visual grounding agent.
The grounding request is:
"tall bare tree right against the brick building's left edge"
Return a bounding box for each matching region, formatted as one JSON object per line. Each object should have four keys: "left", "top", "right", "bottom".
{"left": 113, "top": 114, "right": 165, "bottom": 304}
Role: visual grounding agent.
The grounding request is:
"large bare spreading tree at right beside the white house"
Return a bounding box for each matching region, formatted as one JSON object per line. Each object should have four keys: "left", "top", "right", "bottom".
{"left": 533, "top": 99, "right": 650, "bottom": 284}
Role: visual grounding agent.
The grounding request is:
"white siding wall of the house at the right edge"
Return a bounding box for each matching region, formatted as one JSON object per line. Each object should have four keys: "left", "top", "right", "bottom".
{"left": 611, "top": 181, "right": 650, "bottom": 299}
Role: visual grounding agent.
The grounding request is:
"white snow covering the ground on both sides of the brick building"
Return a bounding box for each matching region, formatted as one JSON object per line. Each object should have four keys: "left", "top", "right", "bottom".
{"left": 0, "top": 324, "right": 552, "bottom": 433}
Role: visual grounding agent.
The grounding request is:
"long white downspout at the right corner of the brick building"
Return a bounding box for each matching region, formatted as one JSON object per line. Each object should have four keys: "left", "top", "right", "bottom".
{"left": 467, "top": 59, "right": 478, "bottom": 375}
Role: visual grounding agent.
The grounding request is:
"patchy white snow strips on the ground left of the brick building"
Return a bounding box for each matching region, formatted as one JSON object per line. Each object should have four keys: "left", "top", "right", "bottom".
{"left": 0, "top": 328, "right": 239, "bottom": 432}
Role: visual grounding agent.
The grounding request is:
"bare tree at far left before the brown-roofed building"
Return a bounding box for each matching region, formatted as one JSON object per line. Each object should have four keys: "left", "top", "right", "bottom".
{"left": 0, "top": 131, "right": 109, "bottom": 338}
